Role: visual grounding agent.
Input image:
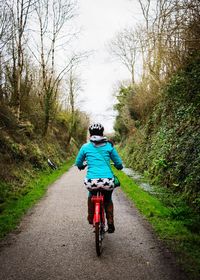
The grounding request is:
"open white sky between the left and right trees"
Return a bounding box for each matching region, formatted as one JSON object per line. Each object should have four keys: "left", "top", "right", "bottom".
{"left": 72, "top": 0, "right": 141, "bottom": 132}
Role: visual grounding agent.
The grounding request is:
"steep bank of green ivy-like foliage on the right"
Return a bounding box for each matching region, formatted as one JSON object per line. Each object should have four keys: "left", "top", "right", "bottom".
{"left": 119, "top": 57, "right": 200, "bottom": 209}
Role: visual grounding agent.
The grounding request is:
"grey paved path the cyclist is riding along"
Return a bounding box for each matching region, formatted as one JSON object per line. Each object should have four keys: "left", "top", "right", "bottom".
{"left": 0, "top": 167, "right": 185, "bottom": 280}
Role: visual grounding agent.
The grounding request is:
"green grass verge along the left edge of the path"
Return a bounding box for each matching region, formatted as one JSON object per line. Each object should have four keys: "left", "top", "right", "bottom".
{"left": 0, "top": 159, "right": 74, "bottom": 239}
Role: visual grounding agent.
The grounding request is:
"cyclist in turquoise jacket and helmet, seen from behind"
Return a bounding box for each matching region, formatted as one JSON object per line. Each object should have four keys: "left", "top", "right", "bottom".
{"left": 75, "top": 123, "right": 123, "bottom": 233}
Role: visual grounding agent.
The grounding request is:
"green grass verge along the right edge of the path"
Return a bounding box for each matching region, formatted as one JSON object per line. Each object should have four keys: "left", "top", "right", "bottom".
{"left": 114, "top": 170, "right": 200, "bottom": 279}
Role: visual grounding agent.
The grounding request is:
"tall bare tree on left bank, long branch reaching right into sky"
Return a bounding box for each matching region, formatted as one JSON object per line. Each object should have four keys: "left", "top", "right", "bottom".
{"left": 36, "top": 0, "right": 78, "bottom": 135}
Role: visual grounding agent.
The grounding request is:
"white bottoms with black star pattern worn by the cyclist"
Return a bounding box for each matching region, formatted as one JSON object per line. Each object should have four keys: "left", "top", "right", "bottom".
{"left": 84, "top": 178, "right": 115, "bottom": 191}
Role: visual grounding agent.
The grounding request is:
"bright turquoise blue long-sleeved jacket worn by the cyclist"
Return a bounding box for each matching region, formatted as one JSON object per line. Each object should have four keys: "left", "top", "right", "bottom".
{"left": 75, "top": 142, "right": 123, "bottom": 179}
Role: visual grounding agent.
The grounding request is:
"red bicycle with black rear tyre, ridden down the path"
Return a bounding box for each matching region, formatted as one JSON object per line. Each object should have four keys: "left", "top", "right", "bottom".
{"left": 91, "top": 189, "right": 106, "bottom": 257}
